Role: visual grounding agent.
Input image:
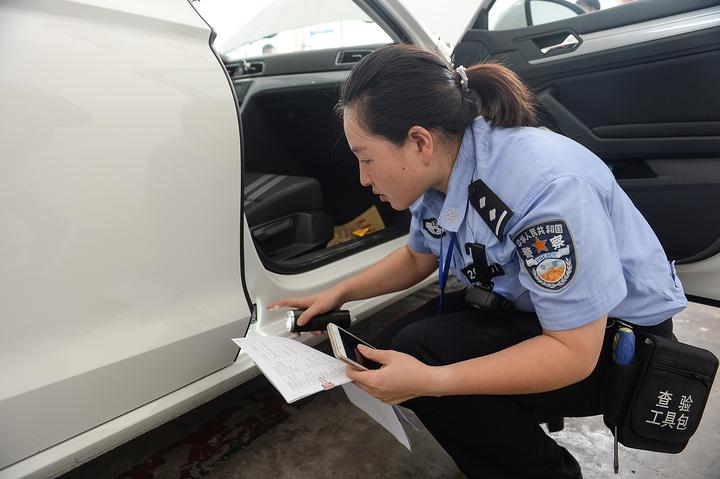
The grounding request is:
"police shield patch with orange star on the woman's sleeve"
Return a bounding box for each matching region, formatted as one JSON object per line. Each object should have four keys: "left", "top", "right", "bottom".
{"left": 513, "top": 220, "right": 577, "bottom": 291}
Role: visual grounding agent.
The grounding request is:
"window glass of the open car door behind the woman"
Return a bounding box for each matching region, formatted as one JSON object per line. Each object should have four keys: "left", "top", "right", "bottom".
{"left": 488, "top": 0, "right": 634, "bottom": 30}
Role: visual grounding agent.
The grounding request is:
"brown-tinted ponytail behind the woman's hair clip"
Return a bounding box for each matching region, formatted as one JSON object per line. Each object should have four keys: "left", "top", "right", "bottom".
{"left": 466, "top": 63, "right": 535, "bottom": 128}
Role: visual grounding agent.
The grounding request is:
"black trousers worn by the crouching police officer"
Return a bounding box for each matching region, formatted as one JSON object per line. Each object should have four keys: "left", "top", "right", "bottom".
{"left": 371, "top": 291, "right": 672, "bottom": 479}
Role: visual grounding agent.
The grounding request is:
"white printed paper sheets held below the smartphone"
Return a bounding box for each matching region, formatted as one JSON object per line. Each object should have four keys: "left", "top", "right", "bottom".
{"left": 233, "top": 336, "right": 414, "bottom": 449}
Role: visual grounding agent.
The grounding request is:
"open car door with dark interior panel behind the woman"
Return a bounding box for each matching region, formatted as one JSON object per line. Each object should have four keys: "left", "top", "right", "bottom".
{"left": 453, "top": 0, "right": 720, "bottom": 304}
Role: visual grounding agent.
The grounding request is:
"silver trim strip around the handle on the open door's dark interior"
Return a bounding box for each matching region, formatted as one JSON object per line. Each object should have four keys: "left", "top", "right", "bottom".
{"left": 528, "top": 6, "right": 720, "bottom": 65}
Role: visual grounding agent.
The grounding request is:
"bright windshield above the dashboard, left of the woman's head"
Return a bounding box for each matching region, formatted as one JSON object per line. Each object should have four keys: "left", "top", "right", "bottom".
{"left": 193, "top": 0, "right": 393, "bottom": 60}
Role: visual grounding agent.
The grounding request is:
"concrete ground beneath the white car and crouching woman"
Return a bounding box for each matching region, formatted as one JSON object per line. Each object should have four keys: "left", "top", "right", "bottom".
{"left": 62, "top": 288, "right": 720, "bottom": 479}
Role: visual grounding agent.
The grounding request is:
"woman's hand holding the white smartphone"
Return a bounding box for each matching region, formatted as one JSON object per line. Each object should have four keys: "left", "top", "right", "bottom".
{"left": 347, "top": 345, "right": 438, "bottom": 404}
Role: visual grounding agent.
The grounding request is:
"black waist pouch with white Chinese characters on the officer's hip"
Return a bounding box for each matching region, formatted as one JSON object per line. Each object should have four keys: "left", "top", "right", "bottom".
{"left": 601, "top": 332, "right": 718, "bottom": 453}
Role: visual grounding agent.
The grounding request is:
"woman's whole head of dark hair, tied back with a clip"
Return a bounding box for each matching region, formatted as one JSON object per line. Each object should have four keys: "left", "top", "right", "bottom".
{"left": 336, "top": 45, "right": 535, "bottom": 145}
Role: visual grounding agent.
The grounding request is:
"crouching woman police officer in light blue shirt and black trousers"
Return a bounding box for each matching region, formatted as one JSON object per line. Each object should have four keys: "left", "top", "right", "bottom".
{"left": 271, "top": 45, "right": 687, "bottom": 478}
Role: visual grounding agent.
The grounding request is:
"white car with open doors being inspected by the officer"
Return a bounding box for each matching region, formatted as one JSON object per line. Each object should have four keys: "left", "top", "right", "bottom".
{"left": 0, "top": 0, "right": 720, "bottom": 478}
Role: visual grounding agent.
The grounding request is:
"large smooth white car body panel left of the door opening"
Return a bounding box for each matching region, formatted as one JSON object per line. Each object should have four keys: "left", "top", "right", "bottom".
{"left": 0, "top": 0, "right": 250, "bottom": 474}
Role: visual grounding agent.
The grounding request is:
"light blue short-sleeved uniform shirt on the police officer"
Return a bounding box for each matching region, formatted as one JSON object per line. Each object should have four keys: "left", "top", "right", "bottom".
{"left": 409, "top": 117, "right": 687, "bottom": 330}
